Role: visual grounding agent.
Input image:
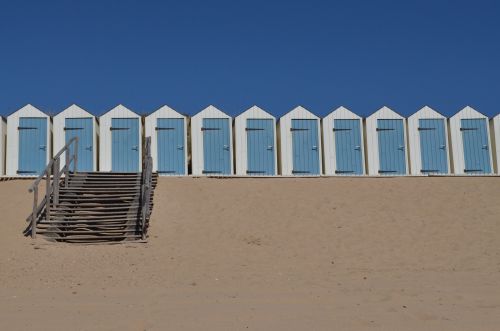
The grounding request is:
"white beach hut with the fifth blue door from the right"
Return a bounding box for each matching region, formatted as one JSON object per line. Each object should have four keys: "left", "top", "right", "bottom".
{"left": 278, "top": 106, "right": 322, "bottom": 176}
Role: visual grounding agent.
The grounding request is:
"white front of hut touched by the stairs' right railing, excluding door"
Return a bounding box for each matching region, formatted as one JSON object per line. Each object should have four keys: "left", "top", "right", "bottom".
{"left": 144, "top": 106, "right": 188, "bottom": 175}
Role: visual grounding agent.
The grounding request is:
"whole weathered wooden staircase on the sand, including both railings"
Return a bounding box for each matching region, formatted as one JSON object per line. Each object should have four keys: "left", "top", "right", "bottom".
{"left": 25, "top": 138, "right": 158, "bottom": 243}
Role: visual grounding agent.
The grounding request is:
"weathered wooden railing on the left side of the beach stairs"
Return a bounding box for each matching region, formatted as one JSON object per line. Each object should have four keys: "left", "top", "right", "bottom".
{"left": 28, "top": 137, "right": 78, "bottom": 238}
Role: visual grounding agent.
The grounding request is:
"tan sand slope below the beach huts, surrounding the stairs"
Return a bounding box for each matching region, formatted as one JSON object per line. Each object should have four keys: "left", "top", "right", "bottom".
{"left": 0, "top": 177, "right": 500, "bottom": 330}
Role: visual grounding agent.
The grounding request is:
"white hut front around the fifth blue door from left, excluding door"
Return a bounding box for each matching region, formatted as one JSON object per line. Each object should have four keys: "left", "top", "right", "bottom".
{"left": 191, "top": 106, "right": 234, "bottom": 176}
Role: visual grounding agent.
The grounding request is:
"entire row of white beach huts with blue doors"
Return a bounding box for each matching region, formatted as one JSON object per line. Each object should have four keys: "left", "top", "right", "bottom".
{"left": 0, "top": 105, "right": 500, "bottom": 176}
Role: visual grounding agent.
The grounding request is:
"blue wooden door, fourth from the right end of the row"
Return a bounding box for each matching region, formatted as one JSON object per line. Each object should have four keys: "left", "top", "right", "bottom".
{"left": 333, "top": 119, "right": 363, "bottom": 175}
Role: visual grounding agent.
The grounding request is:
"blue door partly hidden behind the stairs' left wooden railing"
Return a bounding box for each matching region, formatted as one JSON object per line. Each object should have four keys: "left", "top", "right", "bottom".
{"left": 64, "top": 118, "right": 94, "bottom": 172}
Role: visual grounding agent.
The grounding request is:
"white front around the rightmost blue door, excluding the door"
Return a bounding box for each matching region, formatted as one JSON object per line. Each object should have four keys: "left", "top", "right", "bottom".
{"left": 450, "top": 106, "right": 493, "bottom": 175}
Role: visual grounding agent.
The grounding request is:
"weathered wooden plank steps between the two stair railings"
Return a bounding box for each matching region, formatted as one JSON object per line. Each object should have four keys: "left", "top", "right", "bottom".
{"left": 36, "top": 172, "right": 157, "bottom": 242}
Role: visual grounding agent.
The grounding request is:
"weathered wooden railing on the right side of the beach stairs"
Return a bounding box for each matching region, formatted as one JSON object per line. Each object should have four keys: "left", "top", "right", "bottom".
{"left": 141, "top": 137, "right": 153, "bottom": 240}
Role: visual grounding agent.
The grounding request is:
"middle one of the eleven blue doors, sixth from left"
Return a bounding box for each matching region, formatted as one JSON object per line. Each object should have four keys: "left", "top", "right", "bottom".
{"left": 246, "top": 119, "right": 275, "bottom": 175}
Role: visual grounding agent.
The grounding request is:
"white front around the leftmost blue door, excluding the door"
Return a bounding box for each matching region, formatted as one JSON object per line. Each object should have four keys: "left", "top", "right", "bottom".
{"left": 6, "top": 104, "right": 52, "bottom": 176}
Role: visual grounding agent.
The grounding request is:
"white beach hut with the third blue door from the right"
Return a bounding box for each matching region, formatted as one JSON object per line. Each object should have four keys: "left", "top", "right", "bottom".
{"left": 366, "top": 107, "right": 408, "bottom": 176}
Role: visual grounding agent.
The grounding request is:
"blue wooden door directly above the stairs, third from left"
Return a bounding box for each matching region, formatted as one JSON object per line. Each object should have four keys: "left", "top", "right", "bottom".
{"left": 111, "top": 118, "right": 139, "bottom": 172}
